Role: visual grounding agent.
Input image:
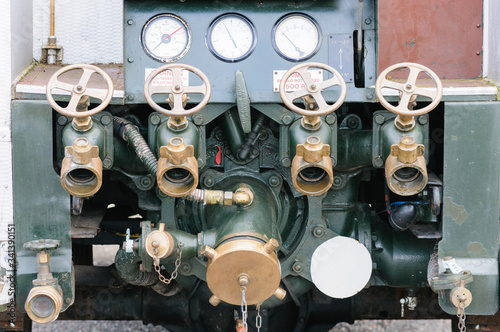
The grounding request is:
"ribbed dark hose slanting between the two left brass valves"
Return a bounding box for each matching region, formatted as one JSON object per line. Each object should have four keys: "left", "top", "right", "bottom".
{"left": 113, "top": 116, "right": 158, "bottom": 177}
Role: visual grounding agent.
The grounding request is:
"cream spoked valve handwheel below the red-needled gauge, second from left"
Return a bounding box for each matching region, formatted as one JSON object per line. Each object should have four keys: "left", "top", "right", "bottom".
{"left": 144, "top": 63, "right": 212, "bottom": 116}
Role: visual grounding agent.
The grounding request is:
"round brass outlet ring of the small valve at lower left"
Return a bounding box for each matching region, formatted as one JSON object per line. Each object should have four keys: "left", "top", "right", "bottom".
{"left": 24, "top": 286, "right": 63, "bottom": 323}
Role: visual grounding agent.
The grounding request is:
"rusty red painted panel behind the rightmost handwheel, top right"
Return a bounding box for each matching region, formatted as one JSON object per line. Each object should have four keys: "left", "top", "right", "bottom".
{"left": 378, "top": 0, "right": 483, "bottom": 79}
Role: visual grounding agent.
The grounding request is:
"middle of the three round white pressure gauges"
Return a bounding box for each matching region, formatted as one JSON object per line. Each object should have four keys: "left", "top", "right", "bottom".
{"left": 207, "top": 14, "right": 257, "bottom": 62}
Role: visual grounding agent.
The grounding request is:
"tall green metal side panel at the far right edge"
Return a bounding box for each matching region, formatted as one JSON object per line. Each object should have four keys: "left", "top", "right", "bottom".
{"left": 439, "top": 102, "right": 500, "bottom": 315}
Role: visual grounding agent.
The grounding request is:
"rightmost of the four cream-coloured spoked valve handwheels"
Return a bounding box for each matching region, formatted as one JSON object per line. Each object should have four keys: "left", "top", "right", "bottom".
{"left": 375, "top": 62, "right": 443, "bottom": 116}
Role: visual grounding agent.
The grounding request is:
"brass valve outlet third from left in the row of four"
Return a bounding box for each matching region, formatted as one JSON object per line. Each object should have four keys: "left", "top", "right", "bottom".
{"left": 292, "top": 136, "right": 333, "bottom": 196}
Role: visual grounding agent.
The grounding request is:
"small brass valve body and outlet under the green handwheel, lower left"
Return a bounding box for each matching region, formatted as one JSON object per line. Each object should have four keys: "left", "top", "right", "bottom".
{"left": 24, "top": 251, "right": 63, "bottom": 323}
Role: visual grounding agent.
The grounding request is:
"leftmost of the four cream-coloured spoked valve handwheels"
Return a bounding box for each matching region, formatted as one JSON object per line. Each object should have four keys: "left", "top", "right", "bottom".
{"left": 47, "top": 64, "right": 113, "bottom": 118}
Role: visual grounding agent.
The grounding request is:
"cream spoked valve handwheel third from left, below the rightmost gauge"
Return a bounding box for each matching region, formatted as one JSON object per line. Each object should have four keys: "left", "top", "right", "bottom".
{"left": 280, "top": 62, "right": 347, "bottom": 116}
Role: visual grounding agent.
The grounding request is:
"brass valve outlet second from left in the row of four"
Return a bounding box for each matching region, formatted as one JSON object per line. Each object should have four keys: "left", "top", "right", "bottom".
{"left": 156, "top": 137, "right": 198, "bottom": 197}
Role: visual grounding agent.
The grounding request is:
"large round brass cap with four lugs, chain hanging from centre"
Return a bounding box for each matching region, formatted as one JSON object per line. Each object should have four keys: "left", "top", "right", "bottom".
{"left": 201, "top": 239, "right": 286, "bottom": 306}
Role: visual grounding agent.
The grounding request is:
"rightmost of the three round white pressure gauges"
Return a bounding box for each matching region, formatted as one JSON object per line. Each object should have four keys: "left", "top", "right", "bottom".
{"left": 272, "top": 14, "right": 321, "bottom": 62}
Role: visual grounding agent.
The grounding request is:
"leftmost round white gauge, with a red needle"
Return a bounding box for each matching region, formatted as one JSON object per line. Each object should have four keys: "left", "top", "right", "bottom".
{"left": 141, "top": 14, "right": 191, "bottom": 62}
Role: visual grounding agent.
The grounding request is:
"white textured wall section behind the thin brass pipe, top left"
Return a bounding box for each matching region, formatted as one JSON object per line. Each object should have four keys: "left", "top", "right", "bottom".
{"left": 32, "top": 0, "right": 123, "bottom": 64}
